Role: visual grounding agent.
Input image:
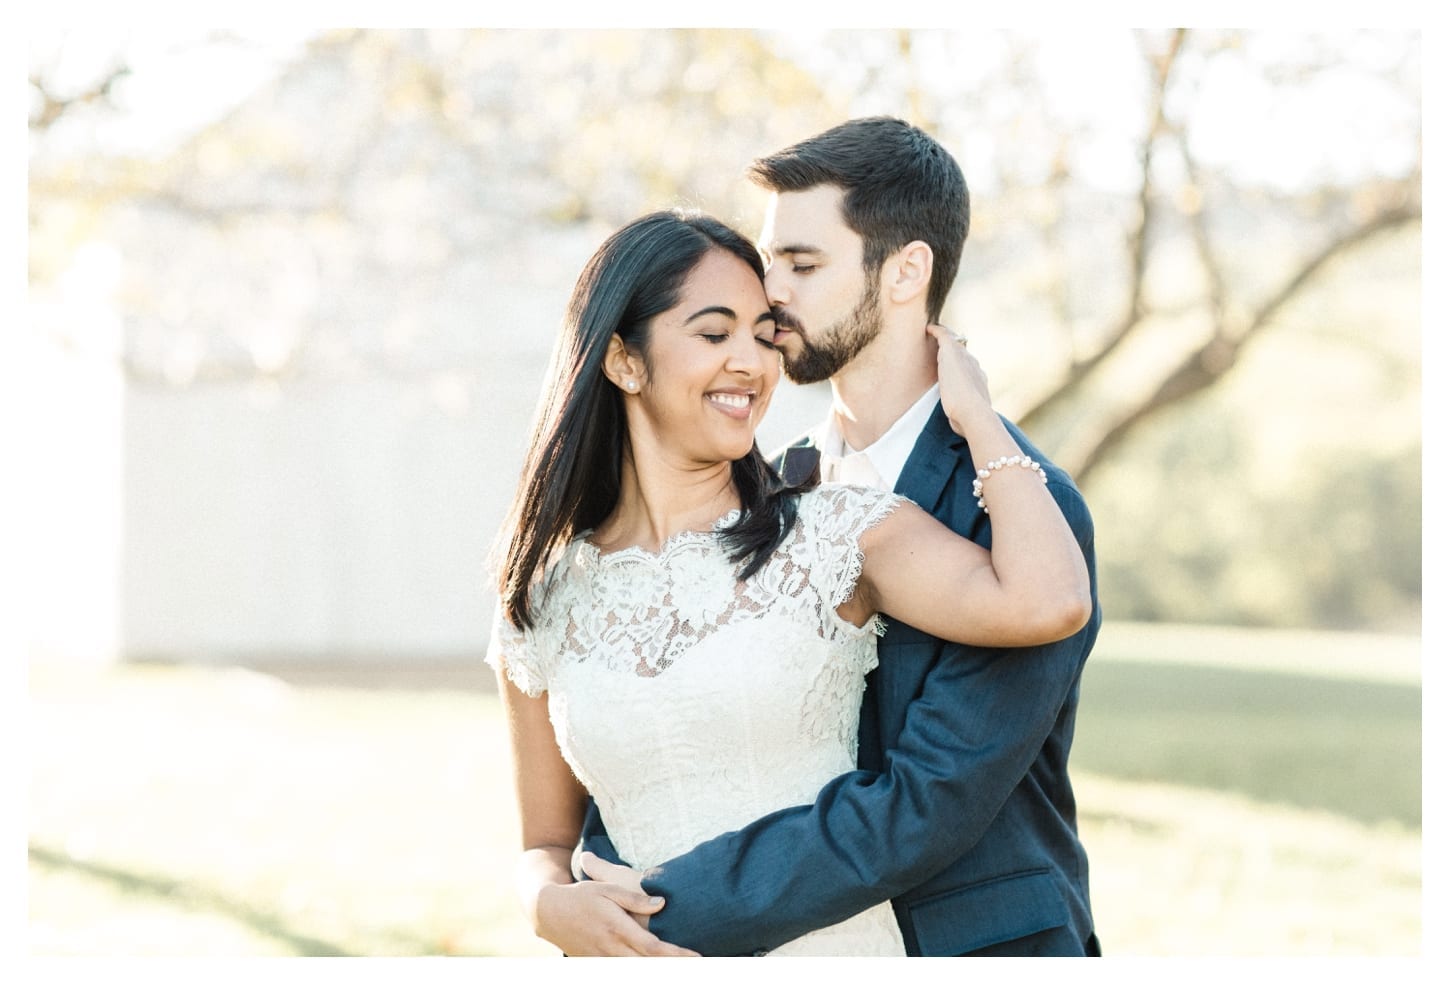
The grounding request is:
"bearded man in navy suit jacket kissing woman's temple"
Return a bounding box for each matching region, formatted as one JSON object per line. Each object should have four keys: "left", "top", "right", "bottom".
{"left": 580, "top": 118, "right": 1102, "bottom": 956}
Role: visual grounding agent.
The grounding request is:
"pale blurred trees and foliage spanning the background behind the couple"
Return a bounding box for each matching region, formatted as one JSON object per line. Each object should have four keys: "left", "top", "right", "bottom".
{"left": 30, "top": 30, "right": 1421, "bottom": 628}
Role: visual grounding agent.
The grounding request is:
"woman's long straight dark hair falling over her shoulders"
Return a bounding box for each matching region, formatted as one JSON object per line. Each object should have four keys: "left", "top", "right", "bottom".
{"left": 499, "top": 212, "right": 817, "bottom": 627}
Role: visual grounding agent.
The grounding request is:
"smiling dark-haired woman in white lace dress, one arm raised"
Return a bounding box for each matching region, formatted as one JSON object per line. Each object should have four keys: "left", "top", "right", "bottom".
{"left": 490, "top": 213, "right": 1089, "bottom": 955}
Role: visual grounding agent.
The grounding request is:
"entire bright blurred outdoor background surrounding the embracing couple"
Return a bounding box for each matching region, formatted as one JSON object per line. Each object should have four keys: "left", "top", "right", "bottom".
{"left": 17, "top": 29, "right": 1421, "bottom": 956}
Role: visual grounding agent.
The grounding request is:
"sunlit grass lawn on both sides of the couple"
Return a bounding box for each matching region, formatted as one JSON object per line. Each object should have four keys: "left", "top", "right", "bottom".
{"left": 29, "top": 627, "right": 1421, "bottom": 957}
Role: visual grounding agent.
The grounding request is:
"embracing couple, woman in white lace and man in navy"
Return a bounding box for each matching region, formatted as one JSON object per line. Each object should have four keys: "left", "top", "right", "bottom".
{"left": 489, "top": 118, "right": 1101, "bottom": 956}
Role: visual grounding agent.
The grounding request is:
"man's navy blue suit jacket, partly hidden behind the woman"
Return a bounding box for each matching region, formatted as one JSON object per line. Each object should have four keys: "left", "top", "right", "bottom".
{"left": 581, "top": 405, "right": 1102, "bottom": 956}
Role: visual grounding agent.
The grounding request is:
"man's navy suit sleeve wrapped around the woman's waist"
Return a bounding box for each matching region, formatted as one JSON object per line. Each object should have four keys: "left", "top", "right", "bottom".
{"left": 644, "top": 483, "right": 1098, "bottom": 955}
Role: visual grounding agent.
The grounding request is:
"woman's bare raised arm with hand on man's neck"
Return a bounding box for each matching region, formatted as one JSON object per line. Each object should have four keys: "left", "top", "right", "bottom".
{"left": 841, "top": 325, "right": 1092, "bottom": 646}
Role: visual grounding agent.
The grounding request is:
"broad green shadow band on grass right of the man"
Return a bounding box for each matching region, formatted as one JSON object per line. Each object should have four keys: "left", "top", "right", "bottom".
{"left": 1073, "top": 660, "right": 1421, "bottom": 828}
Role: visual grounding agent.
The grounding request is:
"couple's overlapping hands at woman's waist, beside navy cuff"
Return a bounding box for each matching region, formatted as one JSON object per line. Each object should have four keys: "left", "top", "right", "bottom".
{"left": 534, "top": 854, "right": 699, "bottom": 957}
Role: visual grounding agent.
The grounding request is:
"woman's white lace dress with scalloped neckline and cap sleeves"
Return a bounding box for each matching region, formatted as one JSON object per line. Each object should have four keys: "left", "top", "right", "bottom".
{"left": 489, "top": 486, "right": 905, "bottom": 955}
